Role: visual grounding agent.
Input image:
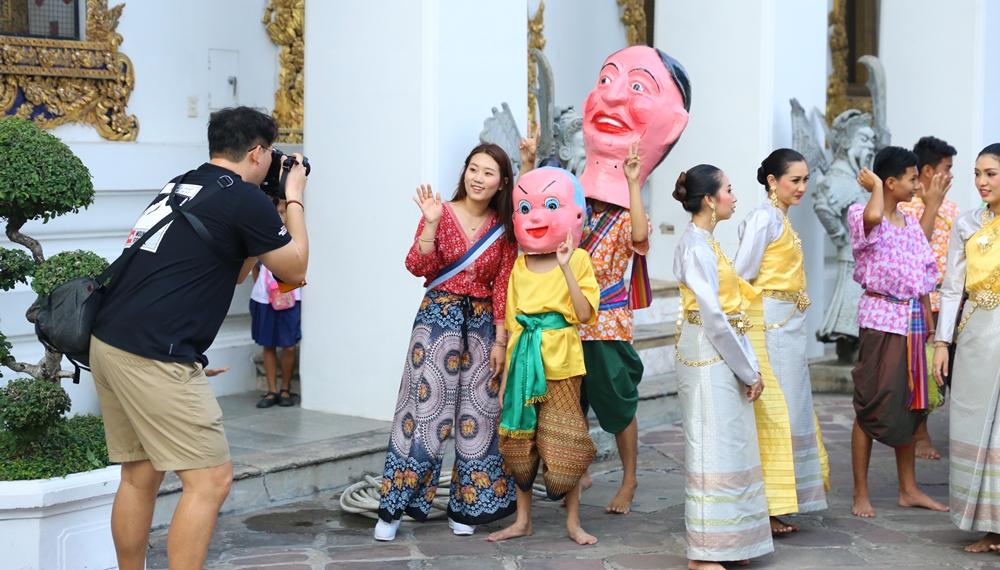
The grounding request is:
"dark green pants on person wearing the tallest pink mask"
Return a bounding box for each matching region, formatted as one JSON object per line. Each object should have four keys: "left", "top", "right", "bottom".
{"left": 580, "top": 340, "right": 642, "bottom": 433}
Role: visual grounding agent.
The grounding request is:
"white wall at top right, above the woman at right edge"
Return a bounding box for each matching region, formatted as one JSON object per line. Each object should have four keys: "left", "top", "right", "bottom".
{"left": 879, "top": 0, "right": 984, "bottom": 210}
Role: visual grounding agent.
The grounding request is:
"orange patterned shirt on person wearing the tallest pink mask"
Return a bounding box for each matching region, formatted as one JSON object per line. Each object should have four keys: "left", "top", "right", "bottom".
{"left": 577, "top": 209, "right": 653, "bottom": 342}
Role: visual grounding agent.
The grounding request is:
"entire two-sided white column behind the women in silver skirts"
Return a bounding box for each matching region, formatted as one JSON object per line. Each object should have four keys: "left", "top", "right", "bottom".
{"left": 650, "top": 0, "right": 827, "bottom": 355}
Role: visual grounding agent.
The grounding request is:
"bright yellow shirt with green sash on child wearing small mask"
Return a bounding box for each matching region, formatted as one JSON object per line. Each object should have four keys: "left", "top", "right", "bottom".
{"left": 504, "top": 249, "right": 601, "bottom": 380}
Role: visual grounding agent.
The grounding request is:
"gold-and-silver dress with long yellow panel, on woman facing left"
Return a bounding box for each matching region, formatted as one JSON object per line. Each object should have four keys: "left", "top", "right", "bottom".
{"left": 735, "top": 202, "right": 830, "bottom": 516}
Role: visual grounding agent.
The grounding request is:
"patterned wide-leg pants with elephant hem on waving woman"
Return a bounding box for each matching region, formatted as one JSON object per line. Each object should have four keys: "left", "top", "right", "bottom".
{"left": 379, "top": 291, "right": 517, "bottom": 525}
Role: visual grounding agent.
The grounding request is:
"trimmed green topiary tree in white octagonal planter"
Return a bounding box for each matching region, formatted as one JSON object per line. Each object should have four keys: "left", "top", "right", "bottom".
{"left": 0, "top": 118, "right": 120, "bottom": 568}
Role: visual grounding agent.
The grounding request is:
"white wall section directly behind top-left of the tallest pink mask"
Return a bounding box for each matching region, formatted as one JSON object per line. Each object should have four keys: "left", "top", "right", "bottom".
{"left": 528, "top": 0, "right": 628, "bottom": 115}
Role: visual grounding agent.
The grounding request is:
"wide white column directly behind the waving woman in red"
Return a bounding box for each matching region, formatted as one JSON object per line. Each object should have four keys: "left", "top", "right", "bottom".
{"left": 300, "top": 0, "right": 527, "bottom": 419}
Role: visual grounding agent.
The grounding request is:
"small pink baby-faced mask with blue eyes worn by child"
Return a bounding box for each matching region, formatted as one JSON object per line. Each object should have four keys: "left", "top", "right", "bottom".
{"left": 513, "top": 167, "right": 586, "bottom": 253}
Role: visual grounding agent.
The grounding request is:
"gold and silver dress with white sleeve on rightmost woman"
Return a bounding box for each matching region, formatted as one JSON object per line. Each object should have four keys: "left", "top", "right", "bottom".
{"left": 935, "top": 208, "right": 1000, "bottom": 532}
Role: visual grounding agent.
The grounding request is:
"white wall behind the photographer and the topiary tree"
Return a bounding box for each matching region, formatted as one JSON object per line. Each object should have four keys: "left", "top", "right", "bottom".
{"left": 0, "top": 0, "right": 278, "bottom": 412}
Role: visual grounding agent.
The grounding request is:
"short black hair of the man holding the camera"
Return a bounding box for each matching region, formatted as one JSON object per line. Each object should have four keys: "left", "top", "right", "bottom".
{"left": 208, "top": 107, "right": 278, "bottom": 162}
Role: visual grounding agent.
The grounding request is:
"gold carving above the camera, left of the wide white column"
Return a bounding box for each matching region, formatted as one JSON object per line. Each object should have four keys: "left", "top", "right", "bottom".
{"left": 263, "top": 0, "right": 306, "bottom": 144}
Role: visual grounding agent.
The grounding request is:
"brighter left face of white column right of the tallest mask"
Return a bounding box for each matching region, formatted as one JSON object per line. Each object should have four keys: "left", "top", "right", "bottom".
{"left": 649, "top": 0, "right": 774, "bottom": 260}
